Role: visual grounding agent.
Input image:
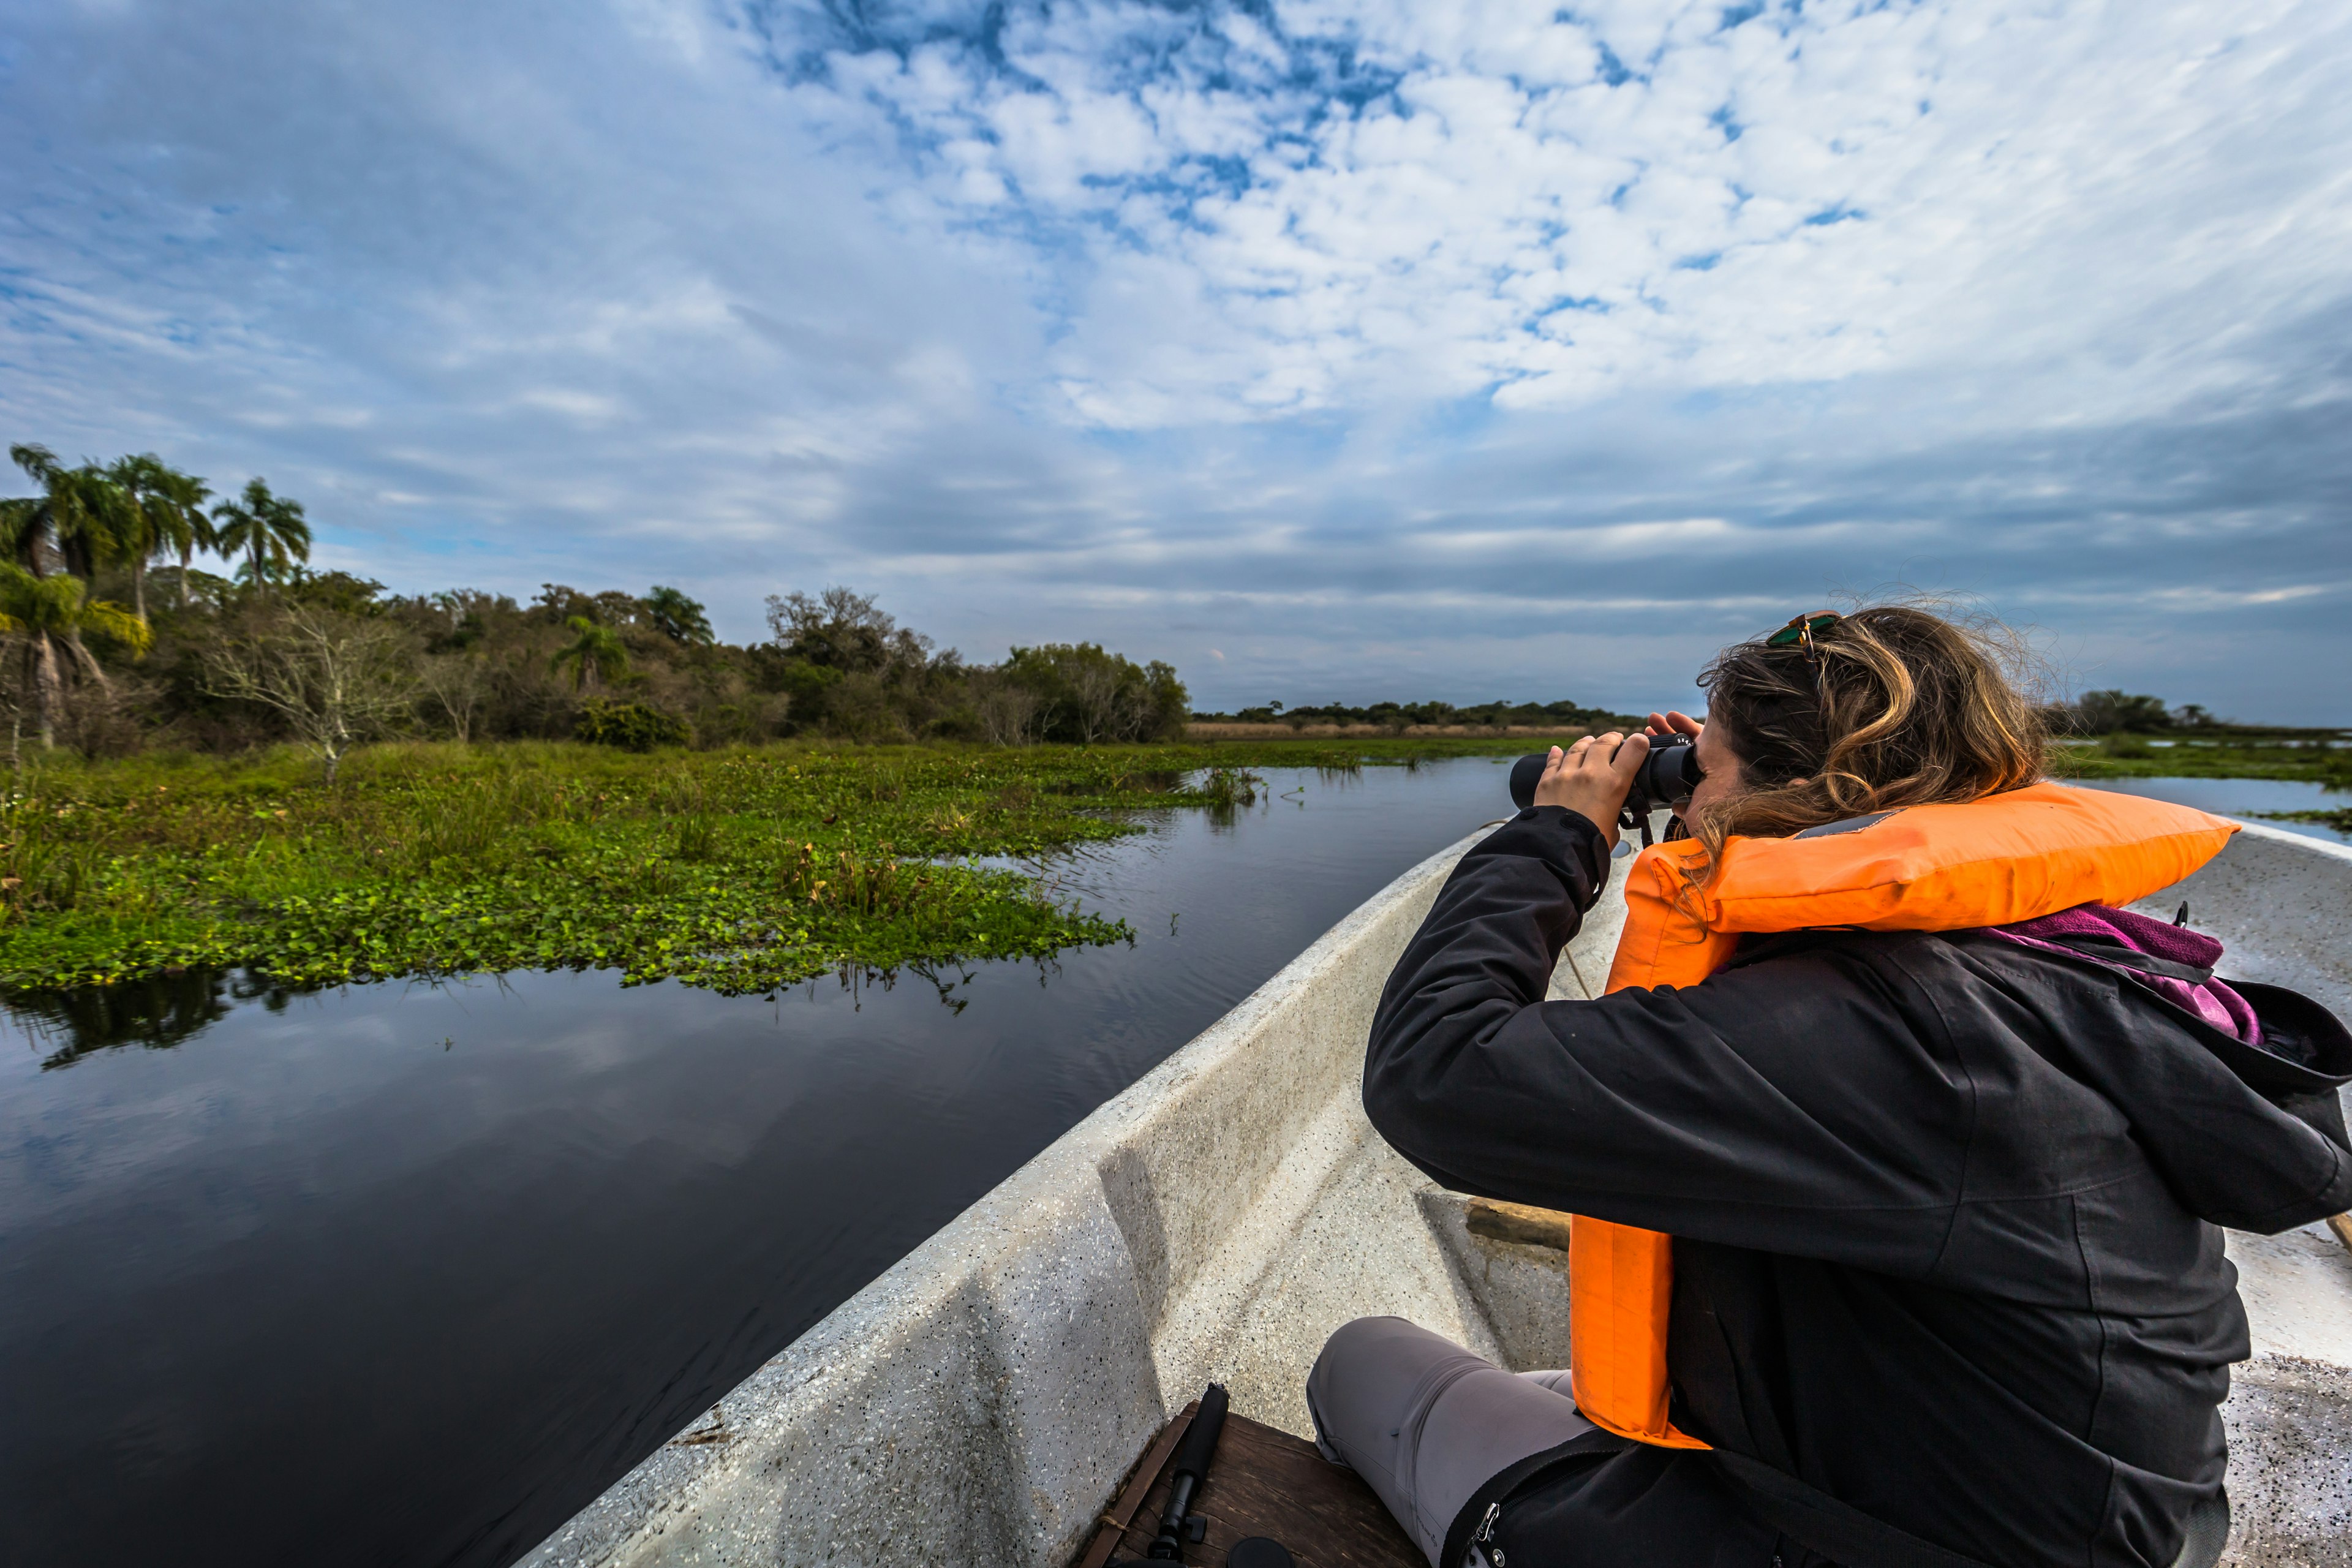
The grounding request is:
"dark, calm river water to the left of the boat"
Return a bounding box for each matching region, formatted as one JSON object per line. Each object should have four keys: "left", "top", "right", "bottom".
{"left": 0, "top": 762, "right": 1507, "bottom": 1568}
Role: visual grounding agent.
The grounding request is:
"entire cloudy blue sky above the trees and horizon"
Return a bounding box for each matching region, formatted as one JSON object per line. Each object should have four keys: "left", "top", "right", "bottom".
{"left": 0, "top": 0, "right": 2352, "bottom": 724}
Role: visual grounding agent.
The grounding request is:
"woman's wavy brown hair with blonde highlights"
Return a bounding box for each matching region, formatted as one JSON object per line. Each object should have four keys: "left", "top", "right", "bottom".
{"left": 1689, "top": 604, "right": 2046, "bottom": 881}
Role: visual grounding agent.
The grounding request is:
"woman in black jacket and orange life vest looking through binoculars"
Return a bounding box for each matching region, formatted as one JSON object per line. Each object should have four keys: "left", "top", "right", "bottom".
{"left": 1308, "top": 606, "right": 2352, "bottom": 1568}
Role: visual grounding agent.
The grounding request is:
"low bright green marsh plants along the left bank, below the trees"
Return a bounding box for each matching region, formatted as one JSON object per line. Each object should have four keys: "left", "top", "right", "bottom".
{"left": 0, "top": 738, "right": 1561, "bottom": 992}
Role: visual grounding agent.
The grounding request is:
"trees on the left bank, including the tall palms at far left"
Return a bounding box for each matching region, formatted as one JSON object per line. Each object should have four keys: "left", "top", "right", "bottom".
{"left": 0, "top": 447, "right": 1190, "bottom": 778}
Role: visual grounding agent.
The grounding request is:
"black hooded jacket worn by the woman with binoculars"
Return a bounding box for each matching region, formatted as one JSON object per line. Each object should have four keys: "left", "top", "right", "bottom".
{"left": 1364, "top": 806, "right": 2352, "bottom": 1568}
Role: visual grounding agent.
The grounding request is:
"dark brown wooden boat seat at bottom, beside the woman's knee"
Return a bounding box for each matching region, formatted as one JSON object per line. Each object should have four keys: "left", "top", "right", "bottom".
{"left": 1080, "top": 1403, "right": 1428, "bottom": 1568}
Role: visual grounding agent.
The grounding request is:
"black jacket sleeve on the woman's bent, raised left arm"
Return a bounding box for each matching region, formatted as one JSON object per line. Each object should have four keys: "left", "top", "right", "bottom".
{"left": 1364, "top": 806, "right": 1973, "bottom": 1276}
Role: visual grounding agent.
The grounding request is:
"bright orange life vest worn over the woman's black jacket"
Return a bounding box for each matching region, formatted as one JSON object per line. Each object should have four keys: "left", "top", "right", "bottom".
{"left": 1569, "top": 783, "right": 2237, "bottom": 1448}
